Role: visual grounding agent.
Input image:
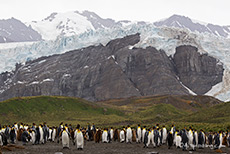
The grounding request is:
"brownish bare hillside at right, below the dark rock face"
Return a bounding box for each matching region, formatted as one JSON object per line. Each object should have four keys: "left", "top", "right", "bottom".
{"left": 96, "top": 95, "right": 221, "bottom": 113}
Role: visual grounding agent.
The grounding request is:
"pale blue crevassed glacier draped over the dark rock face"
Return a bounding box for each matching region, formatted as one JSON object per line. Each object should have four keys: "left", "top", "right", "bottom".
{"left": 0, "top": 23, "right": 230, "bottom": 101}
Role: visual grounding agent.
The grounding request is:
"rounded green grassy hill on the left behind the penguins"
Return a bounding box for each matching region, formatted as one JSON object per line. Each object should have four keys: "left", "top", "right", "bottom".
{"left": 0, "top": 96, "right": 126, "bottom": 124}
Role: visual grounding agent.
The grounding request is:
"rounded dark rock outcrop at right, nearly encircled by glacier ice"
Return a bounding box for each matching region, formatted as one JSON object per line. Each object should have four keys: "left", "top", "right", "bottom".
{"left": 173, "top": 45, "right": 223, "bottom": 94}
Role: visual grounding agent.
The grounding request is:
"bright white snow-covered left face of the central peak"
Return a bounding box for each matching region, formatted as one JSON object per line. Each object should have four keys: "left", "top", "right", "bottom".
{"left": 26, "top": 11, "right": 94, "bottom": 40}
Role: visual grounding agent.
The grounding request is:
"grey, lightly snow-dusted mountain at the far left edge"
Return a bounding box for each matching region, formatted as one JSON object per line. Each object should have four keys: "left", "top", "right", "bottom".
{"left": 0, "top": 18, "right": 41, "bottom": 43}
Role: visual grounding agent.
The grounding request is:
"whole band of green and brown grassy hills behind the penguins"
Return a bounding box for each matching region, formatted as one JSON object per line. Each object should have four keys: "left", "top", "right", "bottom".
{"left": 0, "top": 96, "right": 230, "bottom": 131}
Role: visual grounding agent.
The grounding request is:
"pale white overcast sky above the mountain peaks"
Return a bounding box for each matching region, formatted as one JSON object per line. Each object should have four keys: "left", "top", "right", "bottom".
{"left": 0, "top": 0, "right": 230, "bottom": 25}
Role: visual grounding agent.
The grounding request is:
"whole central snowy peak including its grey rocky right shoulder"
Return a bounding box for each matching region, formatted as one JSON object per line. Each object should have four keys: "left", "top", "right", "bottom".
{"left": 26, "top": 11, "right": 132, "bottom": 40}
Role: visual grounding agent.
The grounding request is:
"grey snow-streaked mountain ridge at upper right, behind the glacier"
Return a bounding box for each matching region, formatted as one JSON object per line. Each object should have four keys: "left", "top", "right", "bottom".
{"left": 154, "top": 15, "right": 230, "bottom": 37}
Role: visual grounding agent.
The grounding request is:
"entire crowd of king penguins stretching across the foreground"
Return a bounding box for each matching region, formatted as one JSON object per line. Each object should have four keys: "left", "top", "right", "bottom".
{"left": 0, "top": 122, "right": 230, "bottom": 151}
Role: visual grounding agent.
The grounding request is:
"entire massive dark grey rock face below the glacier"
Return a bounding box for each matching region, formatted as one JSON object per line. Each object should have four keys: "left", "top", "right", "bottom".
{"left": 0, "top": 34, "right": 223, "bottom": 101}
